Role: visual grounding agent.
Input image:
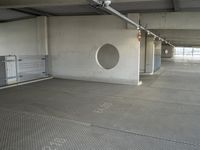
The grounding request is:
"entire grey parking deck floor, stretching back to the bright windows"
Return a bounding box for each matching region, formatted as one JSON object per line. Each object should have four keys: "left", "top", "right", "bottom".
{"left": 0, "top": 60, "right": 200, "bottom": 150}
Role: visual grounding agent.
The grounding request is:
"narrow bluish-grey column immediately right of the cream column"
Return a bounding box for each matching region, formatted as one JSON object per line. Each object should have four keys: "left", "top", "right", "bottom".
{"left": 154, "top": 41, "right": 162, "bottom": 72}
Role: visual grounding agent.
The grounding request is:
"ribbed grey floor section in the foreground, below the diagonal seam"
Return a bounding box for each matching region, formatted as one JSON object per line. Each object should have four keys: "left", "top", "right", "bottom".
{"left": 0, "top": 108, "right": 200, "bottom": 150}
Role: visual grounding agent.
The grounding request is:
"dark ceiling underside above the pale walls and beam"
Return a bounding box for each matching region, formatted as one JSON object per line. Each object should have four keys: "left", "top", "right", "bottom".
{"left": 0, "top": 0, "right": 200, "bottom": 21}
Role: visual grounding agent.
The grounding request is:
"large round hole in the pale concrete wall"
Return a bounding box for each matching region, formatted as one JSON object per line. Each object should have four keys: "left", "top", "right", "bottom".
{"left": 96, "top": 44, "right": 120, "bottom": 69}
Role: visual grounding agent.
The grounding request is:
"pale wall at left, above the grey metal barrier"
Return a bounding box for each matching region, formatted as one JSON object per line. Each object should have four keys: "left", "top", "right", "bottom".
{"left": 0, "top": 17, "right": 47, "bottom": 55}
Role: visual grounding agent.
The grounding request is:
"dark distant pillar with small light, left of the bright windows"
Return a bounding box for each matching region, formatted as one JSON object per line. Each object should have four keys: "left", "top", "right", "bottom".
{"left": 162, "top": 44, "right": 174, "bottom": 58}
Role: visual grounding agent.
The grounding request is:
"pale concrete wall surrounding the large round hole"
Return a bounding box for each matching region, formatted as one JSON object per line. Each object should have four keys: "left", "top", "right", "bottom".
{"left": 49, "top": 16, "right": 140, "bottom": 84}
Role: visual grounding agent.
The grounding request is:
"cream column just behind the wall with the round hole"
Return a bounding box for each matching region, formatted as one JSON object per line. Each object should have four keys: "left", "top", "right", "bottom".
{"left": 145, "top": 36, "right": 155, "bottom": 74}
